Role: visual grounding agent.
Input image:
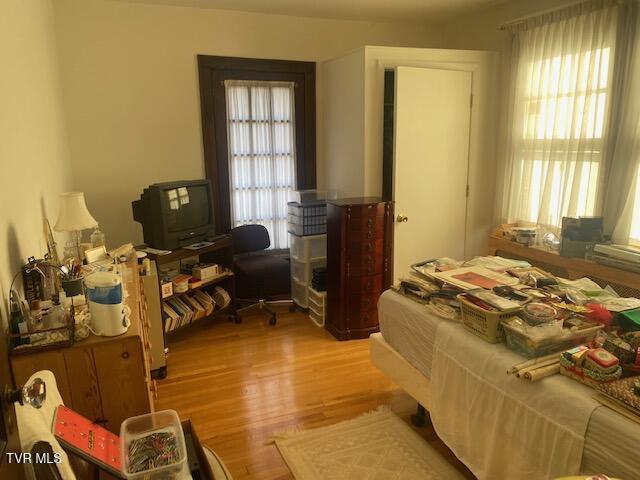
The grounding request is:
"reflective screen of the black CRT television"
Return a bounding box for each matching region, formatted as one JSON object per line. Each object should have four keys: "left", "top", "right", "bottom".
{"left": 162, "top": 185, "right": 211, "bottom": 232}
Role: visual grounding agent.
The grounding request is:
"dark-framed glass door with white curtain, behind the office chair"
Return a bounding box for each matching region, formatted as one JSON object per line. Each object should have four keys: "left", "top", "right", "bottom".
{"left": 198, "top": 55, "right": 316, "bottom": 249}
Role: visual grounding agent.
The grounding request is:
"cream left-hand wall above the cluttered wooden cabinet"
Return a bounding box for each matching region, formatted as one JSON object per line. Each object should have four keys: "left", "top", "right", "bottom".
{"left": 0, "top": 0, "right": 72, "bottom": 414}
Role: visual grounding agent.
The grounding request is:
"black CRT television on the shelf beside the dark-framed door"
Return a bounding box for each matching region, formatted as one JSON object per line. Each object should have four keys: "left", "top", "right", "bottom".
{"left": 131, "top": 180, "right": 215, "bottom": 250}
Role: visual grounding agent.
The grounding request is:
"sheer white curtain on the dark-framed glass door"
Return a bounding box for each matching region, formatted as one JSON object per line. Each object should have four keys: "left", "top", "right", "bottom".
{"left": 225, "top": 80, "right": 296, "bottom": 249}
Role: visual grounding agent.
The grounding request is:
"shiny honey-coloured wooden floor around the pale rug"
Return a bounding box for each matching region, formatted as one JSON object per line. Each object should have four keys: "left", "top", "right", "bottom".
{"left": 156, "top": 312, "right": 473, "bottom": 480}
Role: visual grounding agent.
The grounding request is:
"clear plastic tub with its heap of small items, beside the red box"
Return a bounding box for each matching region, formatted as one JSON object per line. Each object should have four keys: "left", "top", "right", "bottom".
{"left": 120, "top": 410, "right": 190, "bottom": 480}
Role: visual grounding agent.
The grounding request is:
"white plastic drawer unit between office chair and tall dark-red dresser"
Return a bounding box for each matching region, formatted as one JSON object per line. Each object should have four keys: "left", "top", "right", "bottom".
{"left": 289, "top": 233, "right": 327, "bottom": 309}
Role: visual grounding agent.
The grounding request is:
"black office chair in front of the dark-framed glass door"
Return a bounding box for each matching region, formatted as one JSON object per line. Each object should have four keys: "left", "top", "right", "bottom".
{"left": 231, "top": 225, "right": 293, "bottom": 325}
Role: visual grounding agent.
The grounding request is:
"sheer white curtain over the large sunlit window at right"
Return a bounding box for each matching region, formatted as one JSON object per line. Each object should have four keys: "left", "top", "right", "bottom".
{"left": 501, "top": 0, "right": 618, "bottom": 228}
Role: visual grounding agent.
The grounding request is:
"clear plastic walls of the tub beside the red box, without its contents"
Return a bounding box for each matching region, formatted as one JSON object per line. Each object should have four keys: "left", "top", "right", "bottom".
{"left": 120, "top": 410, "right": 188, "bottom": 480}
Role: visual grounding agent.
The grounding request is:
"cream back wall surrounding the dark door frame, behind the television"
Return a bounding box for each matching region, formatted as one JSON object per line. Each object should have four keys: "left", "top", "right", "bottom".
{"left": 55, "top": 0, "right": 439, "bottom": 245}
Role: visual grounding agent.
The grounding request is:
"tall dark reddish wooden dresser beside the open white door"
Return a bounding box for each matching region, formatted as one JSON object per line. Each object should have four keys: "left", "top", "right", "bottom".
{"left": 325, "top": 197, "right": 393, "bottom": 340}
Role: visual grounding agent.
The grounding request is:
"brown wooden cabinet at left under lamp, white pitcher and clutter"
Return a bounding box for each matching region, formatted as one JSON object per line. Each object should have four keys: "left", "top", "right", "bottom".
{"left": 11, "top": 262, "right": 155, "bottom": 434}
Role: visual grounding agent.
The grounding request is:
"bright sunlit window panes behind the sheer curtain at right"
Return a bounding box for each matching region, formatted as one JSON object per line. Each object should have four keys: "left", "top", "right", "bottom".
{"left": 510, "top": 49, "right": 609, "bottom": 226}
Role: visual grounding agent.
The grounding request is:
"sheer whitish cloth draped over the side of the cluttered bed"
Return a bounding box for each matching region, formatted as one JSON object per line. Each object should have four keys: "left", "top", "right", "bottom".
{"left": 430, "top": 322, "right": 600, "bottom": 480}
